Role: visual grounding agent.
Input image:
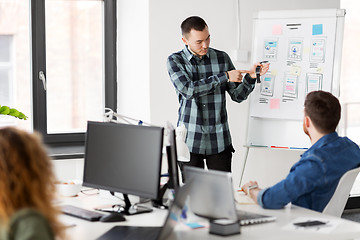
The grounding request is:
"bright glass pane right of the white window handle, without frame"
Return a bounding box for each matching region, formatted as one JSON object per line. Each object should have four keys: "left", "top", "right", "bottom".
{"left": 45, "top": 0, "right": 105, "bottom": 134}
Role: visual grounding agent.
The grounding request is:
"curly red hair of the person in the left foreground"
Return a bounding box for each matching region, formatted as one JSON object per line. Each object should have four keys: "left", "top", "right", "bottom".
{"left": 0, "top": 127, "right": 64, "bottom": 238}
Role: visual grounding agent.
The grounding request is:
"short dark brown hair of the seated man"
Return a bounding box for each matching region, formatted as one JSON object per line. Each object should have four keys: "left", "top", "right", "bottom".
{"left": 304, "top": 91, "right": 341, "bottom": 134}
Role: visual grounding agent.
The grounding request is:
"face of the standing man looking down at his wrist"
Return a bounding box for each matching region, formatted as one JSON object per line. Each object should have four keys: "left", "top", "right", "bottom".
{"left": 182, "top": 27, "right": 210, "bottom": 57}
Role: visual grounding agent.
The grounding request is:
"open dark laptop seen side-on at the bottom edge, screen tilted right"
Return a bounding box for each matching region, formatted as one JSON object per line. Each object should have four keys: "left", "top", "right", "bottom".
{"left": 97, "top": 181, "right": 192, "bottom": 240}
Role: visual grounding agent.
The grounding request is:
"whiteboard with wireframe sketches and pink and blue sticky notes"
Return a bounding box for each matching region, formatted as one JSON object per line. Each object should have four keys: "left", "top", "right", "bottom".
{"left": 247, "top": 9, "right": 345, "bottom": 148}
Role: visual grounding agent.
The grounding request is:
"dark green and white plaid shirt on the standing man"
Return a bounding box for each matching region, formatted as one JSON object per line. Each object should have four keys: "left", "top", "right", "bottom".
{"left": 167, "top": 46, "right": 256, "bottom": 155}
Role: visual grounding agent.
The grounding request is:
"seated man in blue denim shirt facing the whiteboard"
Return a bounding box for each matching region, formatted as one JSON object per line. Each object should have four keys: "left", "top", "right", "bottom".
{"left": 242, "top": 91, "right": 360, "bottom": 212}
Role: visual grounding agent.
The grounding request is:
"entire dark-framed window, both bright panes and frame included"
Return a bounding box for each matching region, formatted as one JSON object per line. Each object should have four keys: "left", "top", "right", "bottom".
{"left": 0, "top": 0, "right": 117, "bottom": 157}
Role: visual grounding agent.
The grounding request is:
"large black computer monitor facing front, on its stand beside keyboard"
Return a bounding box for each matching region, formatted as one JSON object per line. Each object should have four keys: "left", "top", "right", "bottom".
{"left": 83, "top": 121, "right": 164, "bottom": 214}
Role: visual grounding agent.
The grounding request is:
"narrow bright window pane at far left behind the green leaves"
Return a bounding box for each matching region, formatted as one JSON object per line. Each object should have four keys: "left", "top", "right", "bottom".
{"left": 0, "top": 0, "right": 32, "bottom": 131}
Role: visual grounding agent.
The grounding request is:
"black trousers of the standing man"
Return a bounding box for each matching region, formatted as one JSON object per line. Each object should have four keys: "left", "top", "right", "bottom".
{"left": 179, "top": 145, "right": 235, "bottom": 182}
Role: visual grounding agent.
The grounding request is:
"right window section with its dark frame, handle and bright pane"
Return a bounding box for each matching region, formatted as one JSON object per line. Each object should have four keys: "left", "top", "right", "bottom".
{"left": 31, "top": 0, "right": 116, "bottom": 157}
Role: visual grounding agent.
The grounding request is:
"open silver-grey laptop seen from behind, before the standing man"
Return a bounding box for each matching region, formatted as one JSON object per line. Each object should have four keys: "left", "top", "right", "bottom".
{"left": 184, "top": 166, "right": 276, "bottom": 225}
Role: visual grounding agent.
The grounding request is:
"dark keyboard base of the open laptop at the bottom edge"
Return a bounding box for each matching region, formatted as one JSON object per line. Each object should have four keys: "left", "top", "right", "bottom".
{"left": 97, "top": 226, "right": 161, "bottom": 240}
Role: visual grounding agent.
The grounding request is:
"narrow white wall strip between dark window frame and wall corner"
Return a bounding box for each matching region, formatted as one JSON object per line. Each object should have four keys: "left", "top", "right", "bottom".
{"left": 117, "top": 0, "right": 151, "bottom": 122}
